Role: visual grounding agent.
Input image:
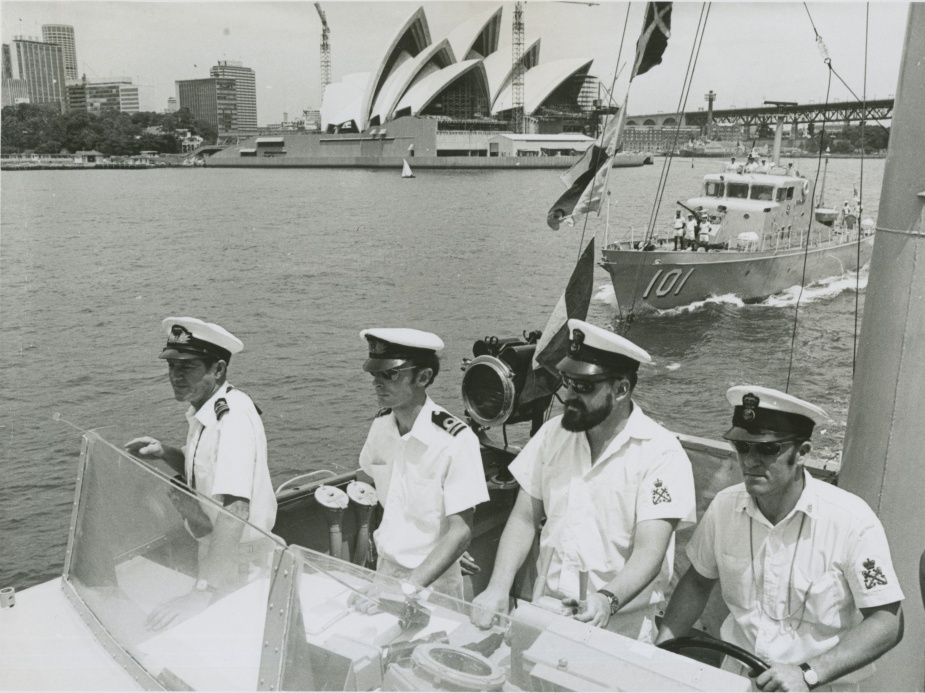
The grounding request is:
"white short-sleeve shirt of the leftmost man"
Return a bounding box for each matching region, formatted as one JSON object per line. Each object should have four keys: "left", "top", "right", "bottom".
{"left": 184, "top": 383, "right": 276, "bottom": 541}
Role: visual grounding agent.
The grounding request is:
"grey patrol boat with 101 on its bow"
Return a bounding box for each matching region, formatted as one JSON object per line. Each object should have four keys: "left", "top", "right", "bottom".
{"left": 601, "top": 125, "right": 874, "bottom": 317}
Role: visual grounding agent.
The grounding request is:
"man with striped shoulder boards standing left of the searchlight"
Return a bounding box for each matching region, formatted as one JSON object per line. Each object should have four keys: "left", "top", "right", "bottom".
{"left": 360, "top": 328, "right": 488, "bottom": 599}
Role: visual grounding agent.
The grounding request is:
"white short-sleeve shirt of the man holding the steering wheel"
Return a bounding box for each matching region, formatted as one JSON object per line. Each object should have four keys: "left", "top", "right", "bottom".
{"left": 687, "top": 472, "right": 903, "bottom": 683}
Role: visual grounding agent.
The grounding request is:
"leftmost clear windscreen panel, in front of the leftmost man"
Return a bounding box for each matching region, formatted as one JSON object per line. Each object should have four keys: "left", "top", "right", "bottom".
{"left": 65, "top": 431, "right": 283, "bottom": 690}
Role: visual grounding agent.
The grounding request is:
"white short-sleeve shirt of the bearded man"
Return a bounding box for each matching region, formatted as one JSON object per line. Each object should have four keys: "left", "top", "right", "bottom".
{"left": 510, "top": 403, "right": 696, "bottom": 639}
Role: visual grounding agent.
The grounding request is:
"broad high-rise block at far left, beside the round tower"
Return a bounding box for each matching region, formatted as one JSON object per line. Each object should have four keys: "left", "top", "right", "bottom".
{"left": 2, "top": 36, "right": 67, "bottom": 112}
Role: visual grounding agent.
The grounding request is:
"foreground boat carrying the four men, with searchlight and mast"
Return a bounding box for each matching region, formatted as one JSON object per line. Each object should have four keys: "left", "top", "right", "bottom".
{"left": 0, "top": 3, "right": 925, "bottom": 691}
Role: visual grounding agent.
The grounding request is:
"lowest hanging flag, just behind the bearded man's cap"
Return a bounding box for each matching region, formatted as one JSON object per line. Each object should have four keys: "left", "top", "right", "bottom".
{"left": 520, "top": 238, "right": 594, "bottom": 404}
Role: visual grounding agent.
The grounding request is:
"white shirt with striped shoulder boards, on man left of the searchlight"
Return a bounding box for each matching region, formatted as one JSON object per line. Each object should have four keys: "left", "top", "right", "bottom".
{"left": 360, "top": 397, "right": 488, "bottom": 569}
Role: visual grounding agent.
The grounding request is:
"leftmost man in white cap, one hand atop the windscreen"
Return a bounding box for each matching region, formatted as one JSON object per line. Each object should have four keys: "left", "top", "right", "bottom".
{"left": 125, "top": 318, "right": 276, "bottom": 630}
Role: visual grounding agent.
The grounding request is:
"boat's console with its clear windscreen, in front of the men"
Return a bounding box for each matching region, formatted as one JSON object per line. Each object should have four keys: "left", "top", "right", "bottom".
{"left": 38, "top": 429, "right": 749, "bottom": 691}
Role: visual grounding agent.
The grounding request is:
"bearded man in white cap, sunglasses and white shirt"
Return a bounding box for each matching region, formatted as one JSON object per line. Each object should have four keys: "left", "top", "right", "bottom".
{"left": 472, "top": 319, "right": 695, "bottom": 642}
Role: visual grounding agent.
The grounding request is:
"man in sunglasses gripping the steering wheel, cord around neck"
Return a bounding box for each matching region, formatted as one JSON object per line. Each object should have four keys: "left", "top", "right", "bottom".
{"left": 658, "top": 386, "right": 903, "bottom": 691}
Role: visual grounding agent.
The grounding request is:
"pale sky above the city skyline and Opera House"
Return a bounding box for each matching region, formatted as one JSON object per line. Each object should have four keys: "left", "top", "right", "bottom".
{"left": 0, "top": 0, "right": 908, "bottom": 125}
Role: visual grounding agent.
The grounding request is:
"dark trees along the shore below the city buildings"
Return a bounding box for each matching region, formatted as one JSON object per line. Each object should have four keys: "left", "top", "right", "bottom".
{"left": 0, "top": 103, "right": 216, "bottom": 156}
